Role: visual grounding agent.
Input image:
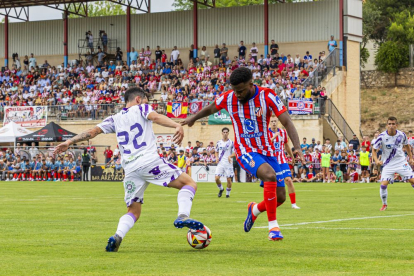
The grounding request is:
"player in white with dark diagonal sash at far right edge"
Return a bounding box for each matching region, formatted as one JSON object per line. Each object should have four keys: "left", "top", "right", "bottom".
{"left": 372, "top": 117, "right": 414, "bottom": 211}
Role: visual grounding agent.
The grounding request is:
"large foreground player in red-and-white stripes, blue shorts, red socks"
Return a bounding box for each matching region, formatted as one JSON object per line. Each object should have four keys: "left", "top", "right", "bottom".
{"left": 181, "top": 67, "right": 303, "bottom": 240}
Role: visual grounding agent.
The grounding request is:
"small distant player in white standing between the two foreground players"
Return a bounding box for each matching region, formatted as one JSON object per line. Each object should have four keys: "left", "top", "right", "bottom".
{"left": 216, "top": 127, "right": 235, "bottom": 198}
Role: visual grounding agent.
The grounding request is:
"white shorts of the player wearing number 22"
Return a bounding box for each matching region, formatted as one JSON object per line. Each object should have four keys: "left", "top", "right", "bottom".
{"left": 124, "top": 158, "right": 182, "bottom": 206}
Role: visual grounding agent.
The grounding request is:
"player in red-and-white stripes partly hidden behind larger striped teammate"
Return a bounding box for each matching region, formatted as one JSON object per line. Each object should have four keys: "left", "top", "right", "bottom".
{"left": 266, "top": 116, "right": 300, "bottom": 209}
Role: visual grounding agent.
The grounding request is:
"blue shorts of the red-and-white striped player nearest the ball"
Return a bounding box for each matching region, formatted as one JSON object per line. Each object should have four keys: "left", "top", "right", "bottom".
{"left": 237, "top": 152, "right": 285, "bottom": 187}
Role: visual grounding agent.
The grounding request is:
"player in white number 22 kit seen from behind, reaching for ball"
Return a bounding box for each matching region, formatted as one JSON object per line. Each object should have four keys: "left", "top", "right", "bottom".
{"left": 54, "top": 87, "right": 204, "bottom": 252}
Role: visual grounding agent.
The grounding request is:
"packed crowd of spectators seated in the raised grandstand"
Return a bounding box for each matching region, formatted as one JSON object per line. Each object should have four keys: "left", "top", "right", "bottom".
{"left": 0, "top": 40, "right": 334, "bottom": 119}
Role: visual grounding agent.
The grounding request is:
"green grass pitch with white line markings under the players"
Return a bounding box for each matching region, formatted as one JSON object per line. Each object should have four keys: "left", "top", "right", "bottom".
{"left": 0, "top": 182, "right": 414, "bottom": 275}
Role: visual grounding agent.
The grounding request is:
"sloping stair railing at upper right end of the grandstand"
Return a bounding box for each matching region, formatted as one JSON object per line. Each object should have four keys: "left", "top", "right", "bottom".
{"left": 303, "top": 49, "right": 339, "bottom": 87}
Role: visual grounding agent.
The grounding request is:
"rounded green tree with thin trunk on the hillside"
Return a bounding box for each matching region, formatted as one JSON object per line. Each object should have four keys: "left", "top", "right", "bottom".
{"left": 375, "top": 40, "right": 409, "bottom": 86}
